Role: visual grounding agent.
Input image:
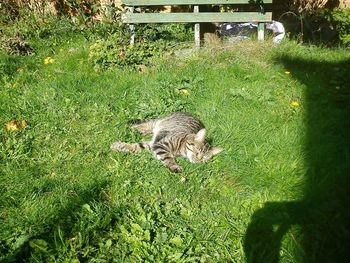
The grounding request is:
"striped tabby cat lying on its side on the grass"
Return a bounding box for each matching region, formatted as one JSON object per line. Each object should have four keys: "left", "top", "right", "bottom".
{"left": 111, "top": 112, "right": 222, "bottom": 173}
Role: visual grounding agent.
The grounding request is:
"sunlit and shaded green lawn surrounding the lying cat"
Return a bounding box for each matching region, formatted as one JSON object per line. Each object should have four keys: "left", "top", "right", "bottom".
{"left": 0, "top": 28, "right": 350, "bottom": 262}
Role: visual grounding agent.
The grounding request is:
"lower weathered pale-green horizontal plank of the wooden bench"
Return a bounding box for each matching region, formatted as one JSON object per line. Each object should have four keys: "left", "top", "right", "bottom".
{"left": 122, "top": 12, "right": 272, "bottom": 24}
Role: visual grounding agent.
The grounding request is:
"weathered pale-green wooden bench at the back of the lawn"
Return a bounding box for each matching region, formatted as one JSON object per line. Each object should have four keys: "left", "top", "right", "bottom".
{"left": 122, "top": 0, "right": 272, "bottom": 47}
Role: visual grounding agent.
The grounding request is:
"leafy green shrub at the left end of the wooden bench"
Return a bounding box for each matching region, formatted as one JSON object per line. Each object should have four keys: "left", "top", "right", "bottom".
{"left": 89, "top": 24, "right": 192, "bottom": 70}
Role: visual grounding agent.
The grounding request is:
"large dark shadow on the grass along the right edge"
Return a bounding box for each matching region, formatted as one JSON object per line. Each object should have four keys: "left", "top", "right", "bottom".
{"left": 244, "top": 56, "right": 350, "bottom": 262}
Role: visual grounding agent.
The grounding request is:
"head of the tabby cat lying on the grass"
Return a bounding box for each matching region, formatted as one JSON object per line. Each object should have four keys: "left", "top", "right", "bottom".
{"left": 186, "top": 129, "right": 223, "bottom": 163}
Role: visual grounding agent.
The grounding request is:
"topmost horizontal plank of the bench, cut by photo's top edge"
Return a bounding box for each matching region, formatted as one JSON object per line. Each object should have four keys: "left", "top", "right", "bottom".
{"left": 122, "top": 0, "right": 273, "bottom": 6}
